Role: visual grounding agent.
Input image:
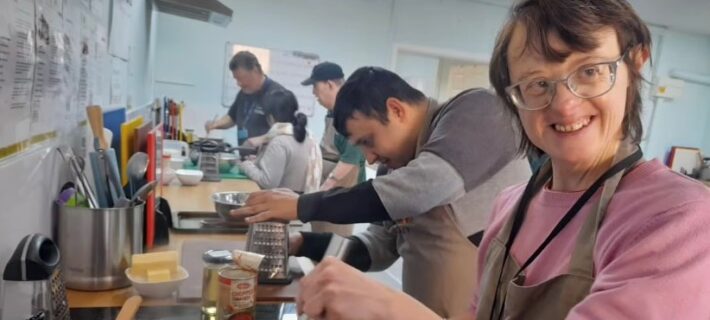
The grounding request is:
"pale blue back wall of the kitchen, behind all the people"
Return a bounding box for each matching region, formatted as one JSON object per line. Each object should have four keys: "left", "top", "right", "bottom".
{"left": 155, "top": 0, "right": 710, "bottom": 159}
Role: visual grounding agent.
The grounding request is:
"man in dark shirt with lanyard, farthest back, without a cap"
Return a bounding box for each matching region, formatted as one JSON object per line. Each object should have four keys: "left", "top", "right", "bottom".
{"left": 205, "top": 51, "right": 285, "bottom": 145}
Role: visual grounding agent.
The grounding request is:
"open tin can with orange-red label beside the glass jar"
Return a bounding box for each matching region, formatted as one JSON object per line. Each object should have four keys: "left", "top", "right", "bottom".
{"left": 217, "top": 266, "right": 257, "bottom": 320}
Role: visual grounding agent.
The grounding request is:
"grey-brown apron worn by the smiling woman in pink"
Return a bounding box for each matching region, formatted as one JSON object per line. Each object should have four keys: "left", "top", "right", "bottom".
{"left": 476, "top": 143, "right": 642, "bottom": 320}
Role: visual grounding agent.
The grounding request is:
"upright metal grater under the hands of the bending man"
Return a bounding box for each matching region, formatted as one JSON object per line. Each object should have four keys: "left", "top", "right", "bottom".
{"left": 247, "top": 222, "right": 291, "bottom": 284}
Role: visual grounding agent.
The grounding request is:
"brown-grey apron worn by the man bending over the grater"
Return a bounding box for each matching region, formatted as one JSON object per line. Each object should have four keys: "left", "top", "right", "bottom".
{"left": 392, "top": 100, "right": 478, "bottom": 318}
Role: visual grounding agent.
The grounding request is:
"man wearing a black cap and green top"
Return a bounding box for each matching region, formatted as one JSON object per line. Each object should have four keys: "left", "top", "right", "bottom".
{"left": 301, "top": 62, "right": 365, "bottom": 235}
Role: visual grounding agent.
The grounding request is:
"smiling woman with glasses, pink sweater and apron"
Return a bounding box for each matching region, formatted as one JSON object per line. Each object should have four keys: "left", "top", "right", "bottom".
{"left": 469, "top": 0, "right": 710, "bottom": 320}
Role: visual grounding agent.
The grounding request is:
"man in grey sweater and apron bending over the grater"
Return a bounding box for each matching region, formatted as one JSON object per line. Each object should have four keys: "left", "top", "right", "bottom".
{"left": 234, "top": 67, "right": 530, "bottom": 317}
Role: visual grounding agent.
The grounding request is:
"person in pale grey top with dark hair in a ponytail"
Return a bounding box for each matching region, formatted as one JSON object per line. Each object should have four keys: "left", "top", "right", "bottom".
{"left": 239, "top": 90, "right": 322, "bottom": 193}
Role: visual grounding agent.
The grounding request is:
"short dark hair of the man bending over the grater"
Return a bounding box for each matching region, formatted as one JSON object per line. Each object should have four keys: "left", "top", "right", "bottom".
{"left": 333, "top": 67, "right": 426, "bottom": 137}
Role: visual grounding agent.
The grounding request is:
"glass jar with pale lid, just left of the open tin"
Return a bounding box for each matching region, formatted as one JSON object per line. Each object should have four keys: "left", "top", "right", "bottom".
{"left": 202, "top": 250, "right": 232, "bottom": 318}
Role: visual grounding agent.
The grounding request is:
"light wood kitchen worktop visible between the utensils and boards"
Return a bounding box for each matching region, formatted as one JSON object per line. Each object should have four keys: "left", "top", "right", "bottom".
{"left": 67, "top": 180, "right": 298, "bottom": 310}
